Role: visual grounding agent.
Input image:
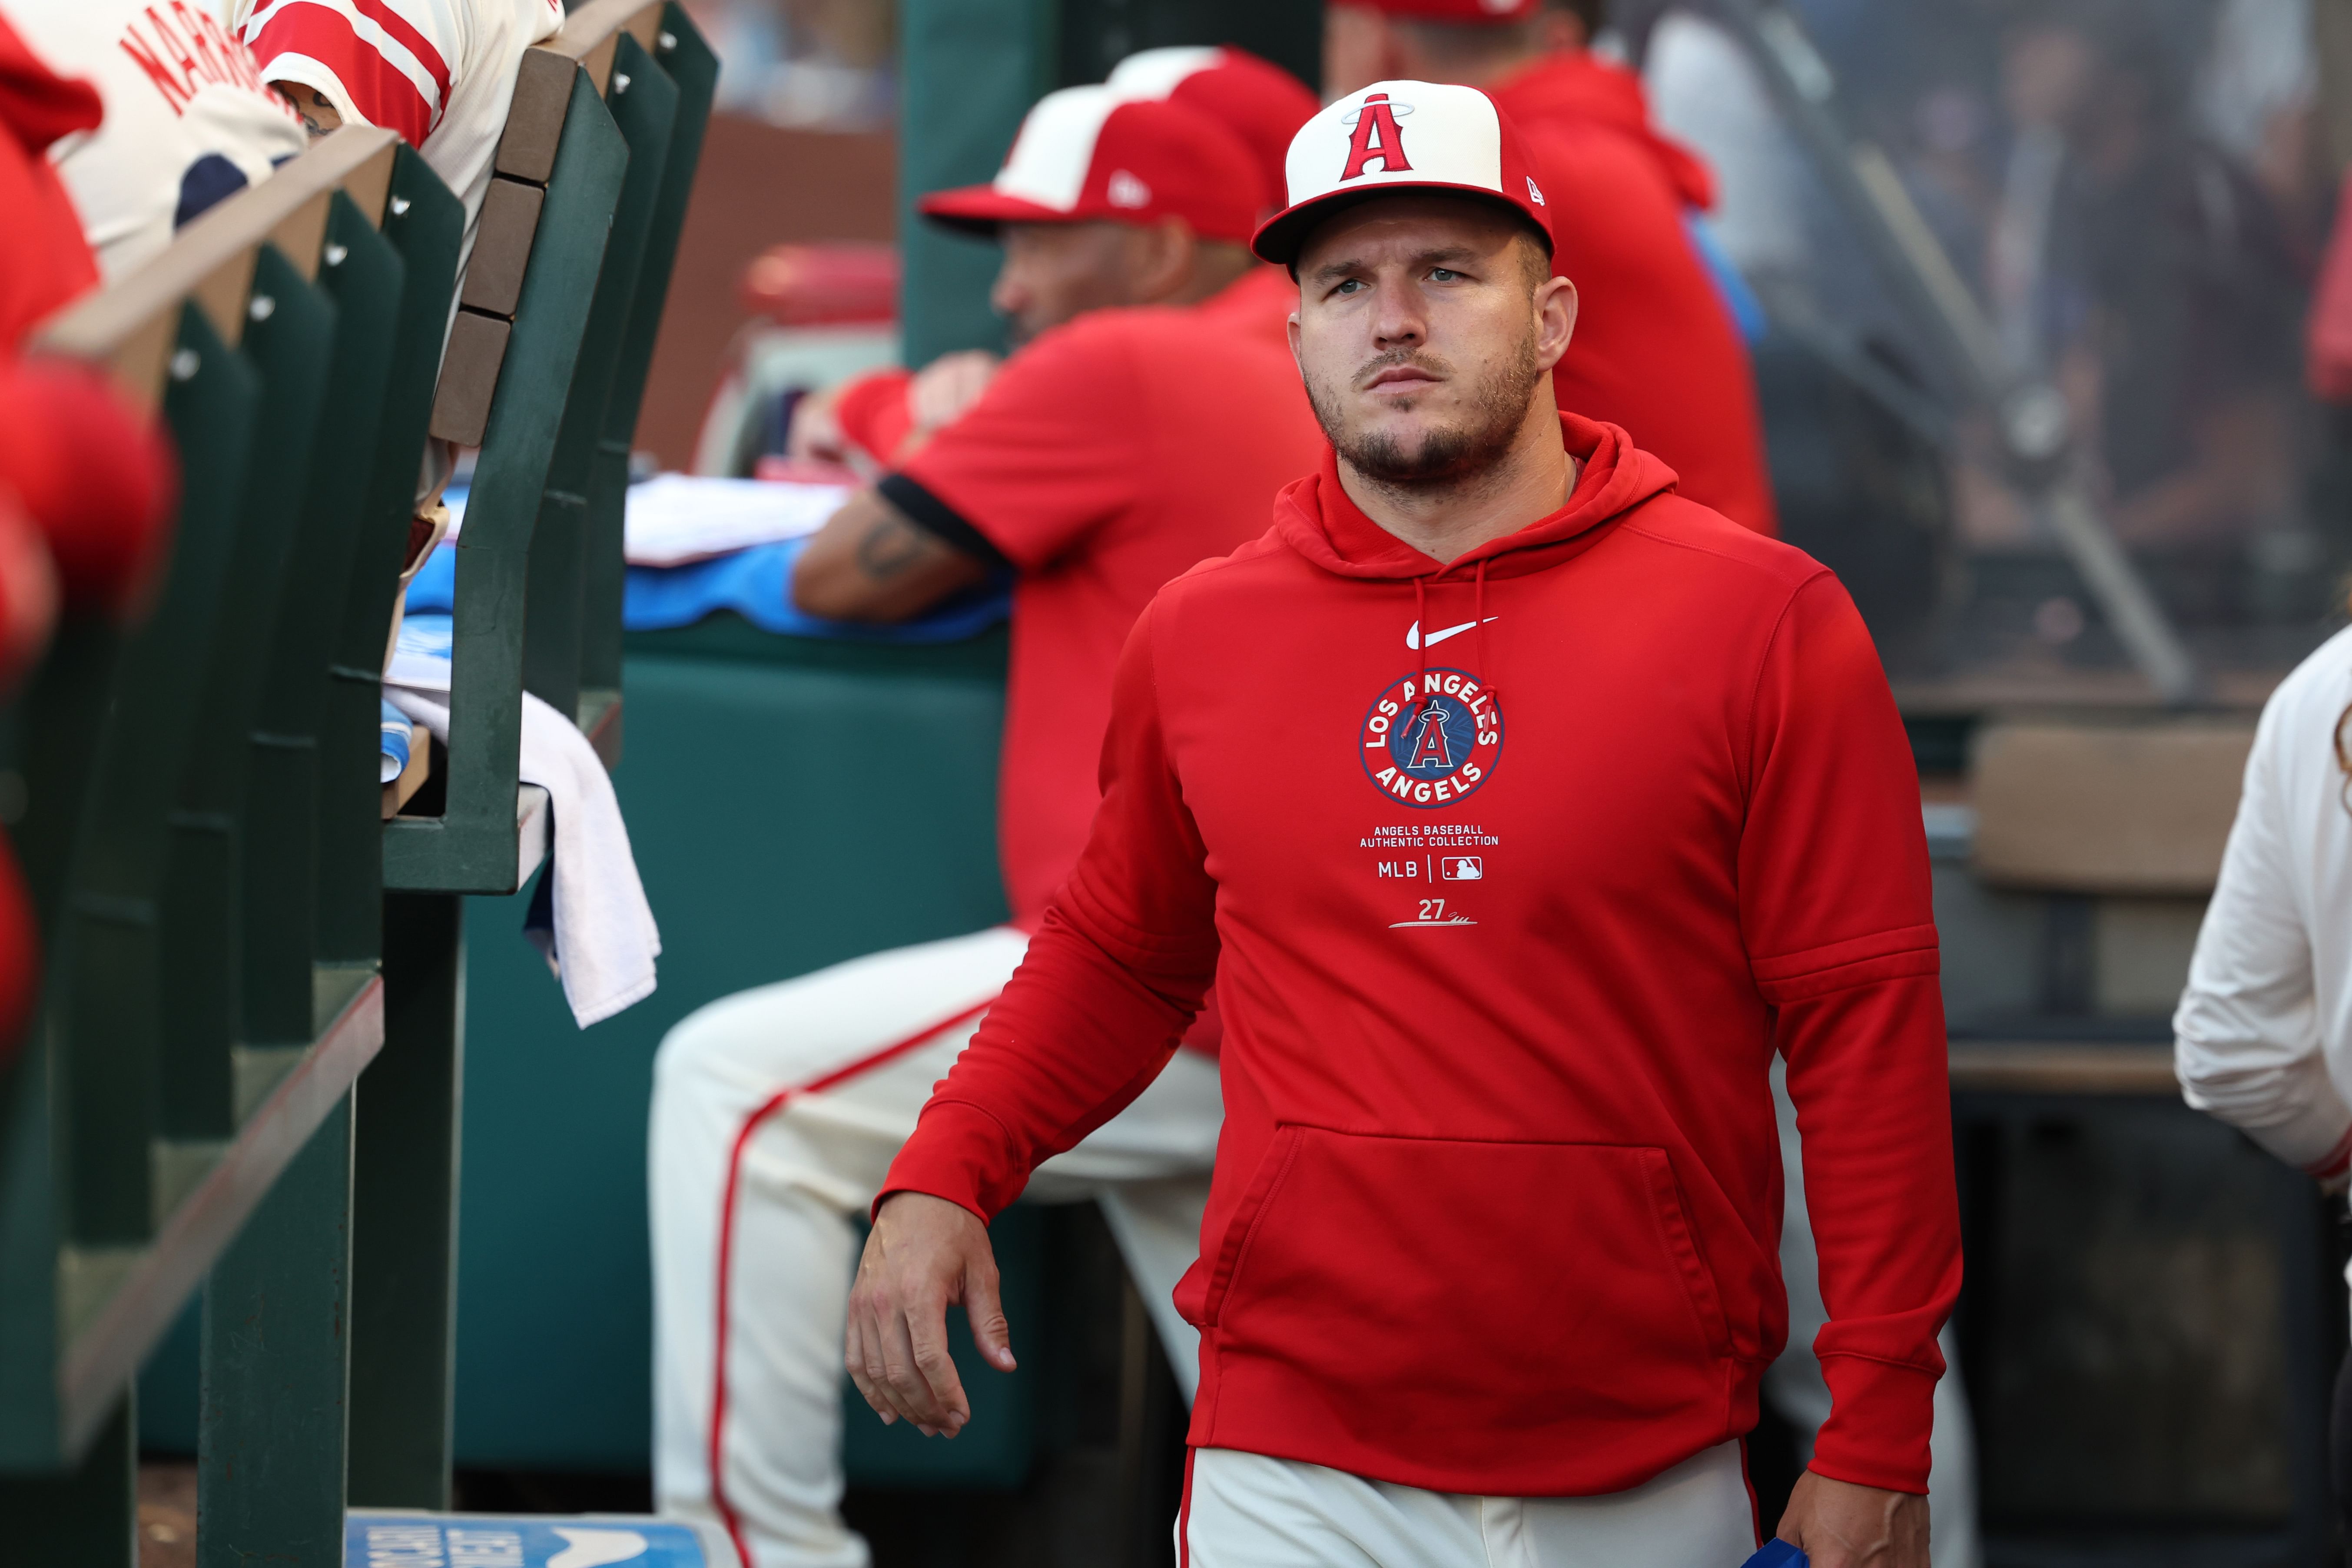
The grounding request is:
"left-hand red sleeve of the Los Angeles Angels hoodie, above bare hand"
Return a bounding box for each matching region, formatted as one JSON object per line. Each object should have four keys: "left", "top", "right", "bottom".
{"left": 875, "top": 609, "right": 1218, "bottom": 1220}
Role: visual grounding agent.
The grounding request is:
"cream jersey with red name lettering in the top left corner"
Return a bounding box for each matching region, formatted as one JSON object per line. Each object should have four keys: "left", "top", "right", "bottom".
{"left": 0, "top": 0, "right": 308, "bottom": 280}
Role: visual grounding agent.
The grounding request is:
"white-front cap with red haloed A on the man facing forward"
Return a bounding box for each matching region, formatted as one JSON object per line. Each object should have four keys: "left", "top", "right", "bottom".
{"left": 1249, "top": 82, "right": 1553, "bottom": 265}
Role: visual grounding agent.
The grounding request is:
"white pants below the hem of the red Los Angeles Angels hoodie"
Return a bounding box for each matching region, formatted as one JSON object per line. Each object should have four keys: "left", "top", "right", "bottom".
{"left": 1176, "top": 1443, "right": 1757, "bottom": 1568}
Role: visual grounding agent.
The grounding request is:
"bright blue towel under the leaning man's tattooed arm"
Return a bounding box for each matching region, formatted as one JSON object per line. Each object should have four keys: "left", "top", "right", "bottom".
{"left": 409, "top": 538, "right": 1012, "bottom": 642}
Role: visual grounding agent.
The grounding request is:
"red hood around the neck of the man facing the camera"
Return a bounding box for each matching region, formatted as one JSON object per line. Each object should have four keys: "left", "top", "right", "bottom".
{"left": 1275, "top": 414, "right": 1677, "bottom": 580}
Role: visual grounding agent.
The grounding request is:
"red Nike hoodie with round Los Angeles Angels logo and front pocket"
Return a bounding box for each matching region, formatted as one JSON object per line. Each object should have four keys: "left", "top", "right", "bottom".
{"left": 884, "top": 416, "right": 1959, "bottom": 1495}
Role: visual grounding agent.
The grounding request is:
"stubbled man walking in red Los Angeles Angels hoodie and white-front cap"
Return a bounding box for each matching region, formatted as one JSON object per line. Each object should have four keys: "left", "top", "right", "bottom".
{"left": 847, "top": 80, "right": 1959, "bottom": 1568}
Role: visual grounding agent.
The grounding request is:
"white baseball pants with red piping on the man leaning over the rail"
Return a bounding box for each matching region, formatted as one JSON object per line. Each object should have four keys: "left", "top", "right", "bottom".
{"left": 649, "top": 928, "right": 1223, "bottom": 1568}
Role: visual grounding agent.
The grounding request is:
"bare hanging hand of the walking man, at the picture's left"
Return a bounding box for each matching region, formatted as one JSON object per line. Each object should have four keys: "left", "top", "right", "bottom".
{"left": 844, "top": 1192, "right": 1014, "bottom": 1436}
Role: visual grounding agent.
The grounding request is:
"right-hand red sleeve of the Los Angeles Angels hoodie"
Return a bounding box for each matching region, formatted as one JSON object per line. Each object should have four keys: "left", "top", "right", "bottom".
{"left": 1741, "top": 573, "right": 1959, "bottom": 1493}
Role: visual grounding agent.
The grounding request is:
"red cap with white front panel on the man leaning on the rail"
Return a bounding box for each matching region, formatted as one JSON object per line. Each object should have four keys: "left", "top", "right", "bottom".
{"left": 915, "top": 87, "right": 1261, "bottom": 245}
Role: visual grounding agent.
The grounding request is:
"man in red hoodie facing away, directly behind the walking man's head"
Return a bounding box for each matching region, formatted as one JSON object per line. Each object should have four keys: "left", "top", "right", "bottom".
{"left": 1324, "top": 0, "right": 1778, "bottom": 534}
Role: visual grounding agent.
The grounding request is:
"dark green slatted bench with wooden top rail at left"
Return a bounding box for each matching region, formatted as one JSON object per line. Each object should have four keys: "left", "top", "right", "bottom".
{"left": 0, "top": 0, "right": 717, "bottom": 1568}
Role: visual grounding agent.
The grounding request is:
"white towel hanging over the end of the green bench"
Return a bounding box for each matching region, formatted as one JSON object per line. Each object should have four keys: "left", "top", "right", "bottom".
{"left": 383, "top": 684, "right": 661, "bottom": 1030}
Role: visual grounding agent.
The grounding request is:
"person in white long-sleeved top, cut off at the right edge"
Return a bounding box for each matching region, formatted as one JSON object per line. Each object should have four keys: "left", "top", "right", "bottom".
{"left": 2173, "top": 611, "right": 2352, "bottom": 1542}
